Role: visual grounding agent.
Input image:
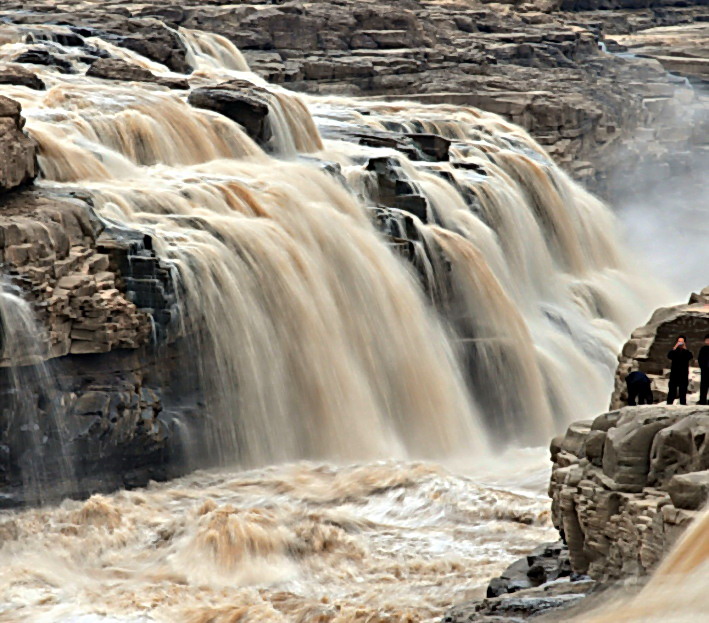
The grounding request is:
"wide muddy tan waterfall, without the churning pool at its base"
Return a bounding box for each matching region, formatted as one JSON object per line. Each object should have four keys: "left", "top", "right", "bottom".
{"left": 0, "top": 25, "right": 650, "bottom": 465}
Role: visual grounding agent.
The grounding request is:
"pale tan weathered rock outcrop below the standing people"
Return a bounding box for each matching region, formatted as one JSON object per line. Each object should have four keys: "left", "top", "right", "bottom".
{"left": 549, "top": 405, "right": 709, "bottom": 580}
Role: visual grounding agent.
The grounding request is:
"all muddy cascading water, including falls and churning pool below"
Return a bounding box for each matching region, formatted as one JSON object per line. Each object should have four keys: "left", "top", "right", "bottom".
{"left": 0, "top": 17, "right": 684, "bottom": 623}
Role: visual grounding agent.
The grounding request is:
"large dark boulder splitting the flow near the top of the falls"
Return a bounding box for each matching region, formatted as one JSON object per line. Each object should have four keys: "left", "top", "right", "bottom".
{"left": 188, "top": 80, "right": 271, "bottom": 145}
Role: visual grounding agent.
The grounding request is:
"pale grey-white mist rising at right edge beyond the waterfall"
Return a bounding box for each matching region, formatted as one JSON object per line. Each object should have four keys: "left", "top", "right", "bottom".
{"left": 609, "top": 86, "right": 709, "bottom": 302}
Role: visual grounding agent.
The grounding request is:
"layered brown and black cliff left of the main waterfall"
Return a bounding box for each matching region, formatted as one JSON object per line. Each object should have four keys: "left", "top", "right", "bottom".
{"left": 0, "top": 183, "right": 194, "bottom": 505}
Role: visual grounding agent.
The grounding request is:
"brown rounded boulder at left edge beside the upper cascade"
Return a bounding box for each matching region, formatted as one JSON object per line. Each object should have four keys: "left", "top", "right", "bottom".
{"left": 0, "top": 95, "right": 37, "bottom": 193}
